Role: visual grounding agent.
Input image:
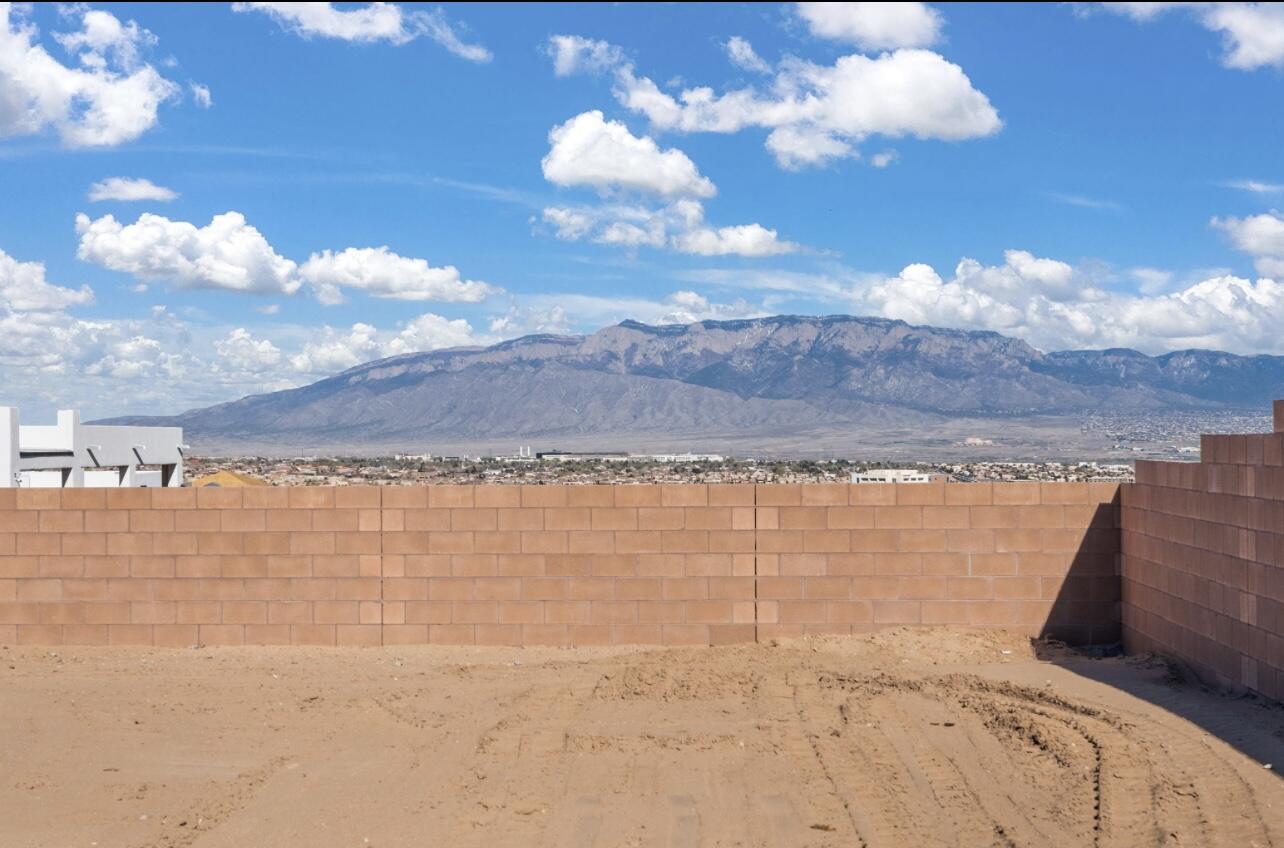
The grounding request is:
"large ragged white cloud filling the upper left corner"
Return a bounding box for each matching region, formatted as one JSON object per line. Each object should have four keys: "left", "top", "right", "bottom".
{"left": 0, "top": 3, "right": 178, "bottom": 148}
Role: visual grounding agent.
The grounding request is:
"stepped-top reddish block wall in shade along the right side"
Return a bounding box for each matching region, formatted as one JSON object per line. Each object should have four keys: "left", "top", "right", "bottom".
{"left": 1122, "top": 426, "right": 1284, "bottom": 699}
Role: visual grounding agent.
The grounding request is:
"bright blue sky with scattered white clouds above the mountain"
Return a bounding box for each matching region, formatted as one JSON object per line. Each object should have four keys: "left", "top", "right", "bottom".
{"left": 0, "top": 3, "right": 1284, "bottom": 416}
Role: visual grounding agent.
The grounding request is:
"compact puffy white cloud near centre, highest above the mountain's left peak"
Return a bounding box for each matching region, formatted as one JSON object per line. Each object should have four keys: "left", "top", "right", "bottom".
{"left": 541, "top": 109, "right": 716, "bottom": 198}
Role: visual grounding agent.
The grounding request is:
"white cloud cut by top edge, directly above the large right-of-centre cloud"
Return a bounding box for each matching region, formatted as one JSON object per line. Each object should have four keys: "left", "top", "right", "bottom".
{"left": 795, "top": 3, "right": 941, "bottom": 51}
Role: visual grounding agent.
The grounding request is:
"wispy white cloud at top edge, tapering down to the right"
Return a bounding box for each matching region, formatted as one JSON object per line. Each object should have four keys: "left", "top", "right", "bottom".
{"left": 232, "top": 3, "right": 493, "bottom": 62}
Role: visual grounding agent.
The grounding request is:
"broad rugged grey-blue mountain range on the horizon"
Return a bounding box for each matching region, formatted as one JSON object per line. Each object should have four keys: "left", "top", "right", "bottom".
{"left": 116, "top": 315, "right": 1284, "bottom": 448}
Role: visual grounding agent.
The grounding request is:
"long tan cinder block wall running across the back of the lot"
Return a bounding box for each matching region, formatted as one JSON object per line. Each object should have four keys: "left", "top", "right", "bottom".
{"left": 0, "top": 483, "right": 1118, "bottom": 646}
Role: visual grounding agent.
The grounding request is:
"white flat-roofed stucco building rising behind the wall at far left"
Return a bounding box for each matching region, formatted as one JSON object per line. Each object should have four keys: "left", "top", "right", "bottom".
{"left": 0, "top": 406, "right": 186, "bottom": 488}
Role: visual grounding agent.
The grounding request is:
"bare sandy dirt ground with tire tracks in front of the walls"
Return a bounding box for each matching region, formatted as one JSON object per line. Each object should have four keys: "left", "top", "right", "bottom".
{"left": 0, "top": 630, "right": 1284, "bottom": 848}
